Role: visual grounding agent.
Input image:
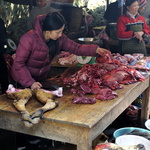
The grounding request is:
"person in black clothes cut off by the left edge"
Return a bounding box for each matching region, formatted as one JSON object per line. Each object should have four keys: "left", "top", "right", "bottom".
{"left": 0, "top": 6, "right": 9, "bottom": 93}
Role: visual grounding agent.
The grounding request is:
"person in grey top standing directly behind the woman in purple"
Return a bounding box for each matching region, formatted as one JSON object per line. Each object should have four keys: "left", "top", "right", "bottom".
{"left": 27, "top": 0, "right": 58, "bottom": 30}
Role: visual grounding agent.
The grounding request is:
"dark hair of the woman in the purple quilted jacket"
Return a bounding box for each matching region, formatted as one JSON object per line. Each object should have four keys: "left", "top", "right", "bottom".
{"left": 42, "top": 12, "right": 66, "bottom": 31}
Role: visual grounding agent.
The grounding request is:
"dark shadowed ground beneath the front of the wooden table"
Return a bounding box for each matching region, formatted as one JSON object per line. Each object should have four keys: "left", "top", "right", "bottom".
{"left": 0, "top": 129, "right": 76, "bottom": 150}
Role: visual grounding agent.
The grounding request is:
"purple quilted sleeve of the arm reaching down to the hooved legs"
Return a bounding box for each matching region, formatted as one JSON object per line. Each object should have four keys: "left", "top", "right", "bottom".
{"left": 11, "top": 36, "right": 35, "bottom": 88}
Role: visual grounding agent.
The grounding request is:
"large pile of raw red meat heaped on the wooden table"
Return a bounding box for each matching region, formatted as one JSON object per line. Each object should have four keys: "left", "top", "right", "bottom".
{"left": 63, "top": 54, "right": 145, "bottom": 103}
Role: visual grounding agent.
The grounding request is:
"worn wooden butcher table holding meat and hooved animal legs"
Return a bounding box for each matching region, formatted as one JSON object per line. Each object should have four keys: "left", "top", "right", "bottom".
{"left": 0, "top": 75, "right": 150, "bottom": 150}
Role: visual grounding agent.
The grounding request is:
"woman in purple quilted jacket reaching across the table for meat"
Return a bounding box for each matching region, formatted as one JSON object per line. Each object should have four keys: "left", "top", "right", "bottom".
{"left": 11, "top": 12, "right": 110, "bottom": 89}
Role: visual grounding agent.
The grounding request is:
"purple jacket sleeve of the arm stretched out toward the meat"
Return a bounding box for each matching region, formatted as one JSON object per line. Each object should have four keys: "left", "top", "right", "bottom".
{"left": 59, "top": 34, "right": 99, "bottom": 56}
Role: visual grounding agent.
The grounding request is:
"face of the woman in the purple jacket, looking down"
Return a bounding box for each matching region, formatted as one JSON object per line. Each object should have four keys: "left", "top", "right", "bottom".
{"left": 44, "top": 25, "right": 65, "bottom": 41}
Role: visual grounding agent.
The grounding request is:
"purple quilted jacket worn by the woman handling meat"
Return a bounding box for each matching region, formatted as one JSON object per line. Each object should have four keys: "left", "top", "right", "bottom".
{"left": 11, "top": 15, "right": 98, "bottom": 87}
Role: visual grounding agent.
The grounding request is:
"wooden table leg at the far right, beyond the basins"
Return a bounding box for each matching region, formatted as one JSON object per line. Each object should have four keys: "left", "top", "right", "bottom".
{"left": 141, "top": 81, "right": 150, "bottom": 127}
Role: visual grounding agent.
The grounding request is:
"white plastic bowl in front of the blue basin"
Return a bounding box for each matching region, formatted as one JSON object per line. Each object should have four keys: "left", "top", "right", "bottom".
{"left": 115, "top": 135, "right": 150, "bottom": 150}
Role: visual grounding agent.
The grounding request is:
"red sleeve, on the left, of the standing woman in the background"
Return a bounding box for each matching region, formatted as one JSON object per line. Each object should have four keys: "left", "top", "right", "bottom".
{"left": 116, "top": 16, "right": 133, "bottom": 40}
